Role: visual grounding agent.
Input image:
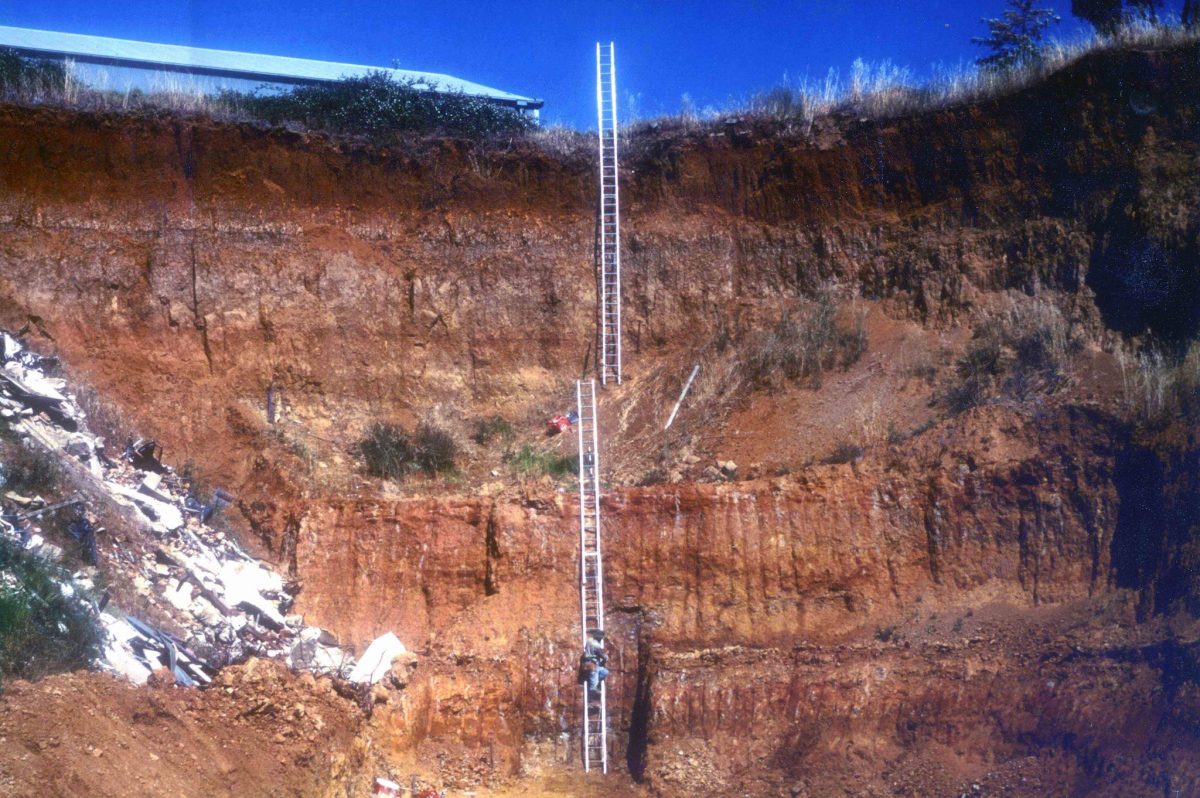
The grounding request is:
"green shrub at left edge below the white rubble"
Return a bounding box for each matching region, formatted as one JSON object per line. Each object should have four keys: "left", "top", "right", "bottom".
{"left": 0, "top": 538, "right": 103, "bottom": 679}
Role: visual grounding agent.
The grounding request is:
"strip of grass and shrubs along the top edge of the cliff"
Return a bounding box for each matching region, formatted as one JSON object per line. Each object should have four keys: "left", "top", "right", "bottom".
{"left": 0, "top": 18, "right": 1200, "bottom": 146}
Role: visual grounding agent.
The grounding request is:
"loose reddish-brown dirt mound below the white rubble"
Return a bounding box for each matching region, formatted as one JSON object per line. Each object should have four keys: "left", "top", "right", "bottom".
{"left": 0, "top": 660, "right": 360, "bottom": 798}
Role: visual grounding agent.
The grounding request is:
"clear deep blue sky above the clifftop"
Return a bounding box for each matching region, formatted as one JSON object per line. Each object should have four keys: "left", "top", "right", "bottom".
{"left": 0, "top": 0, "right": 1178, "bottom": 128}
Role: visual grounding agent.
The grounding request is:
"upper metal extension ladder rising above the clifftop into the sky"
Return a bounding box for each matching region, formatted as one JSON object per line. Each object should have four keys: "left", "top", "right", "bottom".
{"left": 596, "top": 42, "right": 620, "bottom": 385}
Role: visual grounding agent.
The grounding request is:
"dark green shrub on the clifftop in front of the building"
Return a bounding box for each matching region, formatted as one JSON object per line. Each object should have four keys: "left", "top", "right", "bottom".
{"left": 221, "top": 71, "right": 534, "bottom": 138}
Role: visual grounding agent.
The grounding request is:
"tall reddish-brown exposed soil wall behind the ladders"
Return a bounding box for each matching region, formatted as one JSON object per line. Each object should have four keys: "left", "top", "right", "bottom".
{"left": 0, "top": 47, "right": 1200, "bottom": 794}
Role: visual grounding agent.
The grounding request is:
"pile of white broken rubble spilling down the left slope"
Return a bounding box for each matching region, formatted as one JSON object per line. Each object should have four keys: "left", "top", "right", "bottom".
{"left": 0, "top": 332, "right": 369, "bottom": 685}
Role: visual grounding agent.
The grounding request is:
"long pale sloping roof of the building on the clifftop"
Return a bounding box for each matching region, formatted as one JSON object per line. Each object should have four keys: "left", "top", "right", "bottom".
{"left": 0, "top": 25, "right": 542, "bottom": 108}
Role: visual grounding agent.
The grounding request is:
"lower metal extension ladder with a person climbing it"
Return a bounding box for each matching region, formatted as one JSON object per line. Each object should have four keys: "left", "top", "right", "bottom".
{"left": 575, "top": 379, "right": 608, "bottom": 773}
